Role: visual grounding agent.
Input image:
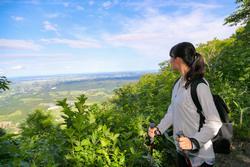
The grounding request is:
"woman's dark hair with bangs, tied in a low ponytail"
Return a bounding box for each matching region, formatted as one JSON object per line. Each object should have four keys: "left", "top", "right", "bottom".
{"left": 170, "top": 42, "right": 205, "bottom": 89}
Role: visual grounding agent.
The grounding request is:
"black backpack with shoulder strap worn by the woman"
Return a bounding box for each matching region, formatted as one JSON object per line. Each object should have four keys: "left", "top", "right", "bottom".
{"left": 191, "top": 79, "right": 233, "bottom": 154}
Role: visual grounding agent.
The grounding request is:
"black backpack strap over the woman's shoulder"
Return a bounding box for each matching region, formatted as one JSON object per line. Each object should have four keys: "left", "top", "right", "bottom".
{"left": 191, "top": 79, "right": 207, "bottom": 132}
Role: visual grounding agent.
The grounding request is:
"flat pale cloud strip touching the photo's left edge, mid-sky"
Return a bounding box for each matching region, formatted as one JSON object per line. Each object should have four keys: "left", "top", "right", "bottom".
{"left": 0, "top": 39, "right": 42, "bottom": 51}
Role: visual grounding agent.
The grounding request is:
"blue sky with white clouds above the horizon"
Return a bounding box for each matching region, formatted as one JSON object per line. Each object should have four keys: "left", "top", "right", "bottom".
{"left": 0, "top": 0, "right": 236, "bottom": 77}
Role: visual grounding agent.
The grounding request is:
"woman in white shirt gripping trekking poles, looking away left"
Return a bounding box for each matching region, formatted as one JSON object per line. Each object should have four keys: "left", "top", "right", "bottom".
{"left": 148, "top": 42, "right": 222, "bottom": 167}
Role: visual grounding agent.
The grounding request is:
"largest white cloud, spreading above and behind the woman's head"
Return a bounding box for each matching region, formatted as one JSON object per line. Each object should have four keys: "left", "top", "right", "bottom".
{"left": 103, "top": 9, "right": 235, "bottom": 58}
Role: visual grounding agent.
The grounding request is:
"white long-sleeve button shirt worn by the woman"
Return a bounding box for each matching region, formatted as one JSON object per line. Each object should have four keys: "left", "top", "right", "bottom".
{"left": 157, "top": 77, "right": 222, "bottom": 166}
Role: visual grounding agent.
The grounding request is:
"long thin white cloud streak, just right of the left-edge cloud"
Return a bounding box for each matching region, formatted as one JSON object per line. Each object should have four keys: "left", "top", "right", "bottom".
{"left": 41, "top": 38, "right": 101, "bottom": 48}
